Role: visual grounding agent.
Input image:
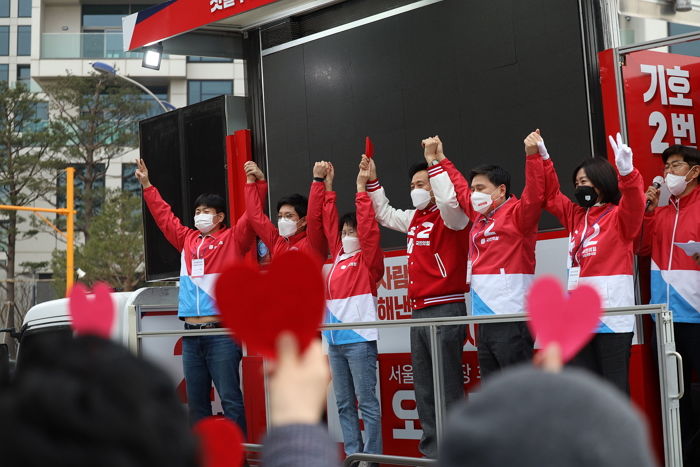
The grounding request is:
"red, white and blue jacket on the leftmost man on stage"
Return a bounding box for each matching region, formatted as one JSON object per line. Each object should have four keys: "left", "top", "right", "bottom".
{"left": 143, "top": 185, "right": 267, "bottom": 318}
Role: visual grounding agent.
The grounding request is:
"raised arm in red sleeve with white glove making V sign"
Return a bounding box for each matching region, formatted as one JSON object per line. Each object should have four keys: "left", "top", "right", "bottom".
{"left": 608, "top": 133, "right": 646, "bottom": 240}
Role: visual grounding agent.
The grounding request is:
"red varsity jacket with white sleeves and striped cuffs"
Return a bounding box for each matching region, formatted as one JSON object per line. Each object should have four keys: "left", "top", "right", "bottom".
{"left": 367, "top": 164, "right": 469, "bottom": 310}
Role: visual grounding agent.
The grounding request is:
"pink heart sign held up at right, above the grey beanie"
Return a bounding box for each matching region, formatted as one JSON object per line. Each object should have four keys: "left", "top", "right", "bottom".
{"left": 527, "top": 277, "right": 603, "bottom": 362}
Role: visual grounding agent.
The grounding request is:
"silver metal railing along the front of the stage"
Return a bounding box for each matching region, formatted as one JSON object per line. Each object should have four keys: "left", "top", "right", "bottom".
{"left": 130, "top": 305, "right": 683, "bottom": 467}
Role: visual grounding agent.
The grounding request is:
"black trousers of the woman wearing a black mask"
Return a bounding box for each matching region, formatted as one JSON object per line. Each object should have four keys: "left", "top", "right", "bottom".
{"left": 569, "top": 332, "right": 634, "bottom": 395}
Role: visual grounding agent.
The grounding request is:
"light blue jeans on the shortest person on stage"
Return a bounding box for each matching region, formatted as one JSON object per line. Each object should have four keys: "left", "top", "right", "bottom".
{"left": 328, "top": 341, "right": 382, "bottom": 455}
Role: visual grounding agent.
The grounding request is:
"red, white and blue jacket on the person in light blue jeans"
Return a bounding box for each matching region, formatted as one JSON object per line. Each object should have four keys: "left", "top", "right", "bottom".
{"left": 323, "top": 191, "right": 384, "bottom": 345}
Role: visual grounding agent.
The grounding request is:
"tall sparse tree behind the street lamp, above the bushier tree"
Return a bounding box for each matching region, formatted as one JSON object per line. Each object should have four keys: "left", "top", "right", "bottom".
{"left": 44, "top": 74, "right": 149, "bottom": 240}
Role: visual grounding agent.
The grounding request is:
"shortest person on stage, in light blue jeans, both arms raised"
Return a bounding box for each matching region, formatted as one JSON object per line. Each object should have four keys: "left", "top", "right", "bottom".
{"left": 323, "top": 158, "right": 384, "bottom": 455}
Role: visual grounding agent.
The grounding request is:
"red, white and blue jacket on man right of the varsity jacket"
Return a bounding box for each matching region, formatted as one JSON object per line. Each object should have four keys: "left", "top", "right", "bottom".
{"left": 442, "top": 154, "right": 545, "bottom": 315}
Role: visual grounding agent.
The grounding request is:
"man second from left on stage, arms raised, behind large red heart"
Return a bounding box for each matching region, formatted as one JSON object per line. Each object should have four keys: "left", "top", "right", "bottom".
{"left": 243, "top": 161, "right": 328, "bottom": 261}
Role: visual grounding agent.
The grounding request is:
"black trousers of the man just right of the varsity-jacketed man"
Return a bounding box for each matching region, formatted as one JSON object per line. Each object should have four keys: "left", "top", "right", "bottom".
{"left": 477, "top": 322, "right": 534, "bottom": 380}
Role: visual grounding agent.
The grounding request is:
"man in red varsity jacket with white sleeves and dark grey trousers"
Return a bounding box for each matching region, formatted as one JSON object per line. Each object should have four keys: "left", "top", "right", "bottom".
{"left": 363, "top": 137, "right": 469, "bottom": 458}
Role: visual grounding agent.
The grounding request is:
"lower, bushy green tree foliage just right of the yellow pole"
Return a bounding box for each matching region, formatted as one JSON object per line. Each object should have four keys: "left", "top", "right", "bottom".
{"left": 51, "top": 190, "right": 146, "bottom": 293}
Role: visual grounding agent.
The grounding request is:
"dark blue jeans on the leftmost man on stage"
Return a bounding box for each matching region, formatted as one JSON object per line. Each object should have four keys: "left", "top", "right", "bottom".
{"left": 182, "top": 336, "right": 246, "bottom": 433}
